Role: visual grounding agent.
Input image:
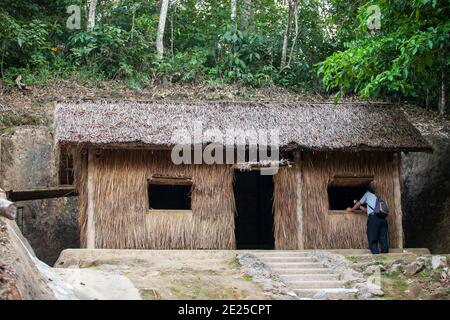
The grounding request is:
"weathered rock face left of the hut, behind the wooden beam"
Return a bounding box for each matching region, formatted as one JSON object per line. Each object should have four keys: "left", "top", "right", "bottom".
{"left": 0, "top": 126, "right": 79, "bottom": 265}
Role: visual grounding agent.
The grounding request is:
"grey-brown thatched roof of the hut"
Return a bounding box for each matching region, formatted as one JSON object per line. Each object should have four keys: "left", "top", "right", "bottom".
{"left": 55, "top": 101, "right": 431, "bottom": 151}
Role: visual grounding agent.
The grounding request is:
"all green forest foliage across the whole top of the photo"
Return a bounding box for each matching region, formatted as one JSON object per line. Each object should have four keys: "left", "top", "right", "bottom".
{"left": 0, "top": 0, "right": 450, "bottom": 109}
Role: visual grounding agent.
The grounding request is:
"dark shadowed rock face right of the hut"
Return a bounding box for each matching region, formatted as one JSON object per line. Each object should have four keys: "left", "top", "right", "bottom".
{"left": 402, "top": 135, "right": 450, "bottom": 253}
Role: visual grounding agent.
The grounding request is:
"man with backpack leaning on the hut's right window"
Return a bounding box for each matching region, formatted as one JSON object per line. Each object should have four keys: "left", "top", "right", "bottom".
{"left": 347, "top": 184, "right": 389, "bottom": 254}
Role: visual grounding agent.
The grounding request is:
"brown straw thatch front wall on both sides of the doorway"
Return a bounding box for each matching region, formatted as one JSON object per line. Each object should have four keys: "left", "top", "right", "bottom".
{"left": 76, "top": 149, "right": 401, "bottom": 250}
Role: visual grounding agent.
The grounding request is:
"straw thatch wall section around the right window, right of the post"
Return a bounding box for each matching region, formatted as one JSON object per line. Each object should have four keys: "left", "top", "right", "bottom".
{"left": 302, "top": 152, "right": 401, "bottom": 249}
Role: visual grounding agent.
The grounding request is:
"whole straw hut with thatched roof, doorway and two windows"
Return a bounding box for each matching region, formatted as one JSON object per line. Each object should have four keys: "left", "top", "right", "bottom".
{"left": 55, "top": 101, "right": 430, "bottom": 249}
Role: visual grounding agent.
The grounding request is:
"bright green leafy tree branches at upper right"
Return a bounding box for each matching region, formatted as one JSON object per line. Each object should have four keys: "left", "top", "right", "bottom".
{"left": 318, "top": 0, "right": 450, "bottom": 103}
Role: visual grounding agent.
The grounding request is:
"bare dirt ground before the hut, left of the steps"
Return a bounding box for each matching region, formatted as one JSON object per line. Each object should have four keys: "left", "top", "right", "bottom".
{"left": 55, "top": 250, "right": 282, "bottom": 300}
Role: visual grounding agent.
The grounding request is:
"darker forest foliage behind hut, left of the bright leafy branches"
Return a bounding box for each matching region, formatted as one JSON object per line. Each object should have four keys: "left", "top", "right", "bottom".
{"left": 0, "top": 0, "right": 336, "bottom": 90}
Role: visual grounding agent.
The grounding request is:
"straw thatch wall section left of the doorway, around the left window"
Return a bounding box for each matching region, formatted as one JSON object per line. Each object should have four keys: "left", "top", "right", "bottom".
{"left": 77, "top": 150, "right": 235, "bottom": 249}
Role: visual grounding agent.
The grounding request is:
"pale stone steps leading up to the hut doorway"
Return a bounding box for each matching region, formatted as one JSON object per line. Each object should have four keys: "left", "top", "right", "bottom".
{"left": 251, "top": 251, "right": 356, "bottom": 299}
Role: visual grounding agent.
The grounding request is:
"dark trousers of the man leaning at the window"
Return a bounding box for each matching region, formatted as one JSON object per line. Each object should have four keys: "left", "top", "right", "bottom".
{"left": 367, "top": 214, "right": 389, "bottom": 254}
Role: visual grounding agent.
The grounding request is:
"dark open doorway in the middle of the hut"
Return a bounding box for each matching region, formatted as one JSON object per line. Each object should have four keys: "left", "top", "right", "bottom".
{"left": 234, "top": 171, "right": 275, "bottom": 249}
